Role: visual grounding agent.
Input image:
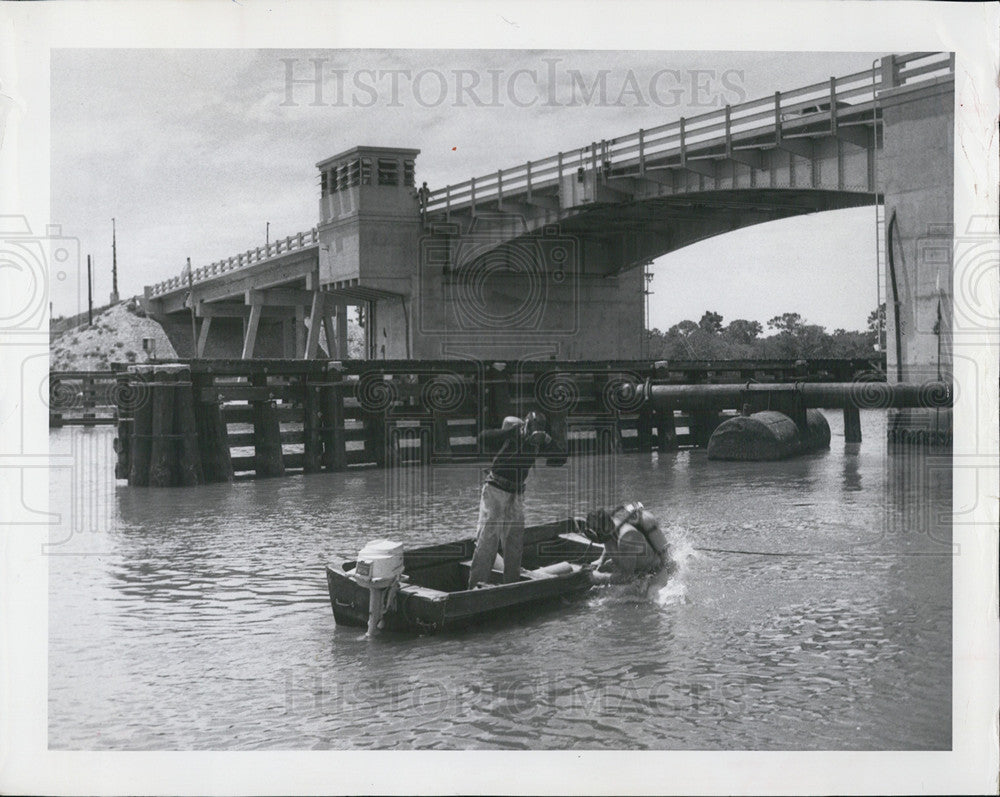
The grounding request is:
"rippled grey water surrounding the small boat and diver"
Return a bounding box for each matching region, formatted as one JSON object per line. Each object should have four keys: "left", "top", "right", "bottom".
{"left": 49, "top": 412, "right": 952, "bottom": 750}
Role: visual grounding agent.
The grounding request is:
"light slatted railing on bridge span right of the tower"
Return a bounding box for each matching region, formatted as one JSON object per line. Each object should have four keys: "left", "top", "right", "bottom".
{"left": 427, "top": 53, "right": 954, "bottom": 214}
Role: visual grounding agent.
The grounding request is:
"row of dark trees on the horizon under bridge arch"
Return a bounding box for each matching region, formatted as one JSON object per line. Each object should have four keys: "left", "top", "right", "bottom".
{"left": 646, "top": 302, "right": 885, "bottom": 360}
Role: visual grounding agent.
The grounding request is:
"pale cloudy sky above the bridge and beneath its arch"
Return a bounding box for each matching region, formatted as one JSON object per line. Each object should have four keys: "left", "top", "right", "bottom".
{"left": 51, "top": 49, "right": 879, "bottom": 330}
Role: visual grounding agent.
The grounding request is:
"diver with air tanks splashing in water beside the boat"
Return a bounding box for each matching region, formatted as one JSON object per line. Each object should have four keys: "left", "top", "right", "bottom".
{"left": 586, "top": 501, "right": 675, "bottom": 585}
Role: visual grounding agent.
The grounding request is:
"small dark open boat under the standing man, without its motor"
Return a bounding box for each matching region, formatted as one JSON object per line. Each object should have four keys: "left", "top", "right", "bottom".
{"left": 326, "top": 518, "right": 604, "bottom": 633}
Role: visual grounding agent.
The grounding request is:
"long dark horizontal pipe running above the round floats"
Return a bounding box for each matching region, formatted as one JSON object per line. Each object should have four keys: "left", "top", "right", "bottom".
{"left": 637, "top": 382, "right": 952, "bottom": 410}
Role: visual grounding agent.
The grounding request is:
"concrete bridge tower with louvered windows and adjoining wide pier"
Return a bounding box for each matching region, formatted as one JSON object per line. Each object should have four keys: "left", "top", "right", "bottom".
{"left": 317, "top": 146, "right": 643, "bottom": 359}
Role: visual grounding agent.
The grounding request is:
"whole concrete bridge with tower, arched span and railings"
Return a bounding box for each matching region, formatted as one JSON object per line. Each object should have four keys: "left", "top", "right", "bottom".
{"left": 145, "top": 53, "right": 954, "bottom": 394}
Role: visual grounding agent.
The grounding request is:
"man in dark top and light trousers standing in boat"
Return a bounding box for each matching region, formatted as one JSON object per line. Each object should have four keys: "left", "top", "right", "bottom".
{"left": 469, "top": 412, "right": 552, "bottom": 589}
